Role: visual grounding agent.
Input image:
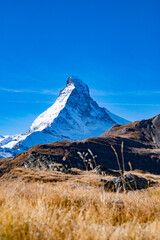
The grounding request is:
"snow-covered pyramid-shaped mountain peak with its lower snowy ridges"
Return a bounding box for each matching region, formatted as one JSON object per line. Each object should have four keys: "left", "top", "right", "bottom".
{"left": 0, "top": 77, "right": 129, "bottom": 157}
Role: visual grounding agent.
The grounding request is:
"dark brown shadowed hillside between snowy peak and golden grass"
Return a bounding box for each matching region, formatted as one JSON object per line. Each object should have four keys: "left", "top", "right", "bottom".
{"left": 0, "top": 115, "right": 160, "bottom": 174}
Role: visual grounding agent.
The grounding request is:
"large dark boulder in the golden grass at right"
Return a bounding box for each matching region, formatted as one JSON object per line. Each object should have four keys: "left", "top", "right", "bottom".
{"left": 104, "top": 173, "right": 156, "bottom": 192}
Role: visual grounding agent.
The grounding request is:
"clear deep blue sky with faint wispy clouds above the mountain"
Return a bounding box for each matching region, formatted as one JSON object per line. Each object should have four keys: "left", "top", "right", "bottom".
{"left": 0, "top": 0, "right": 160, "bottom": 135}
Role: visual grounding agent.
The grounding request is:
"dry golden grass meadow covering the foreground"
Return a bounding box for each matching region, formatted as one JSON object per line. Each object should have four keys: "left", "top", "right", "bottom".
{"left": 0, "top": 168, "right": 160, "bottom": 240}
